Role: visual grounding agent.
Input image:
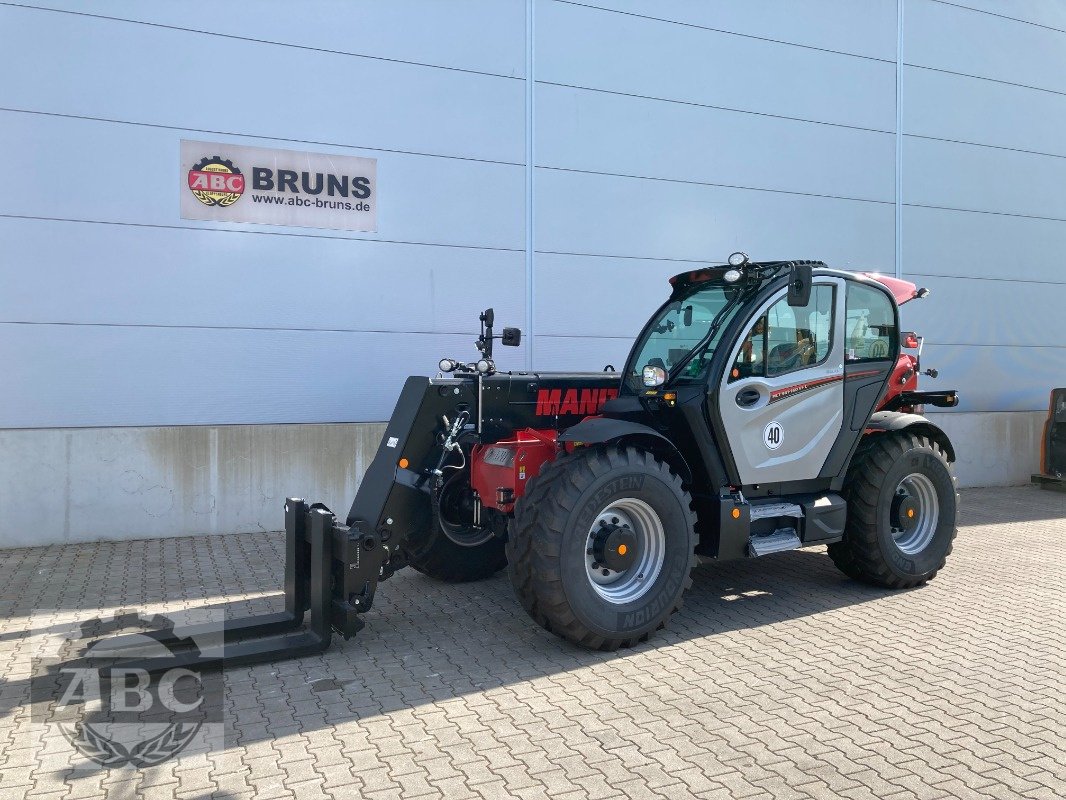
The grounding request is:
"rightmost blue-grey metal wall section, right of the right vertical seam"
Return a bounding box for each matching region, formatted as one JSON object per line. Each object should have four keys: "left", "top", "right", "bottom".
{"left": 902, "top": 0, "right": 1066, "bottom": 411}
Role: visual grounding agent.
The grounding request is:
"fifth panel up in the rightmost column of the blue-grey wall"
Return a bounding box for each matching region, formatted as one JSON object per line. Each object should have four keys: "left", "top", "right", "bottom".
{"left": 903, "top": 65, "right": 1066, "bottom": 157}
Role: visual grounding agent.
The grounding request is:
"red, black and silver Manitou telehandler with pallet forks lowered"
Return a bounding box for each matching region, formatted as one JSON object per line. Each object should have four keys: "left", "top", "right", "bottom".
{"left": 101, "top": 253, "right": 958, "bottom": 670}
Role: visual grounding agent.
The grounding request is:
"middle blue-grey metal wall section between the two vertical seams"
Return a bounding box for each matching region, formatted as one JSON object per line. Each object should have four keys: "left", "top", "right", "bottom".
{"left": 534, "top": 0, "right": 897, "bottom": 368}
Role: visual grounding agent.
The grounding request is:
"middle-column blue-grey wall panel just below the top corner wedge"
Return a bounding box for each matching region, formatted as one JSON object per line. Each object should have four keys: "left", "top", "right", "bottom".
{"left": 536, "top": 2, "right": 895, "bottom": 130}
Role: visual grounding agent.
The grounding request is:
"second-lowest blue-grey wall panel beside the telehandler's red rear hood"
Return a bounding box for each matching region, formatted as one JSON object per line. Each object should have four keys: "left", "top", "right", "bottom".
{"left": 903, "top": 275, "right": 1066, "bottom": 347}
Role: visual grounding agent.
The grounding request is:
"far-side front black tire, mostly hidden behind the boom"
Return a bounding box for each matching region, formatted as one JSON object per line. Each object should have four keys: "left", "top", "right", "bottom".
{"left": 404, "top": 470, "right": 507, "bottom": 583}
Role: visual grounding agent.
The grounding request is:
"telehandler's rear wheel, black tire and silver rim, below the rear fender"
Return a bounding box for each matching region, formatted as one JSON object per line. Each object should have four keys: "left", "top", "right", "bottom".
{"left": 828, "top": 439, "right": 958, "bottom": 589}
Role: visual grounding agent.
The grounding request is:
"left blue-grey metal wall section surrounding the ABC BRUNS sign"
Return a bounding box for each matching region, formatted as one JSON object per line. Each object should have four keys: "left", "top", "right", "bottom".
{"left": 0, "top": 0, "right": 526, "bottom": 427}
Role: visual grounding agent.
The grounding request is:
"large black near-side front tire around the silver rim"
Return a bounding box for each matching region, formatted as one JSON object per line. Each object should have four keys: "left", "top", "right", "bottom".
{"left": 507, "top": 447, "right": 696, "bottom": 651}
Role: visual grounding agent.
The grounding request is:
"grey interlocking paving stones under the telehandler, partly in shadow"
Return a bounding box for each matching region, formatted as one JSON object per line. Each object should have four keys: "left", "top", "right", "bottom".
{"left": 0, "top": 487, "right": 1066, "bottom": 800}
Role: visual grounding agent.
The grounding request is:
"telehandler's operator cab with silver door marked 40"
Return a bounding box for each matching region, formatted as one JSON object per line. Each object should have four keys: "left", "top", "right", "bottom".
{"left": 604, "top": 253, "right": 914, "bottom": 497}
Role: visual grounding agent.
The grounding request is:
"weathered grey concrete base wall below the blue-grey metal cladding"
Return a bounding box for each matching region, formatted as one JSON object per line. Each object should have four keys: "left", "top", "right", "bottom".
{"left": 0, "top": 412, "right": 1046, "bottom": 547}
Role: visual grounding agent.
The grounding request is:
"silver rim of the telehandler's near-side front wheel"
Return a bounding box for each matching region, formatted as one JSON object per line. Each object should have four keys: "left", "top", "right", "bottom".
{"left": 585, "top": 497, "right": 666, "bottom": 605}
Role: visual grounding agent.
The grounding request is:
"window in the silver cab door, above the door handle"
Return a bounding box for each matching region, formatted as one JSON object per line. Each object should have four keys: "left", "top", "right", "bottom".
{"left": 729, "top": 285, "right": 836, "bottom": 381}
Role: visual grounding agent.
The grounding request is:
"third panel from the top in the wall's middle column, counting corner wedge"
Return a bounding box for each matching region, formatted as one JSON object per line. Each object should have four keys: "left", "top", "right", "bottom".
{"left": 536, "top": 85, "right": 895, "bottom": 202}
